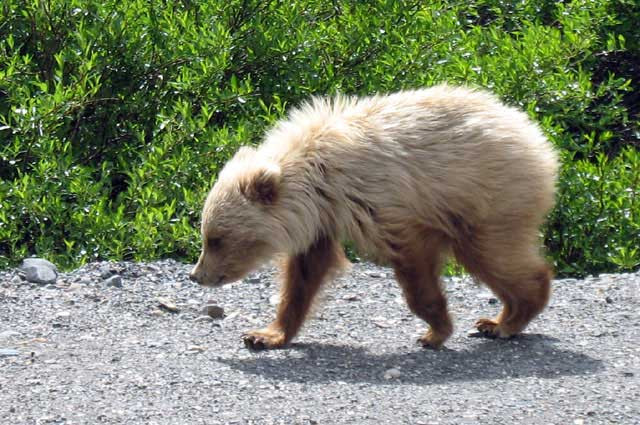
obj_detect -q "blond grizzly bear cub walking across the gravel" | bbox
[191,85,558,349]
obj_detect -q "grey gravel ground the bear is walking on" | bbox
[0,261,640,424]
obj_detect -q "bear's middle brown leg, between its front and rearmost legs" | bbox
[394,235,453,349]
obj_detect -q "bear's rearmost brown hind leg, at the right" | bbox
[454,225,552,338]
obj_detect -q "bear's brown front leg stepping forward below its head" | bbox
[244,238,348,350]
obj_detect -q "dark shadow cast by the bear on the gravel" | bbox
[218,334,603,385]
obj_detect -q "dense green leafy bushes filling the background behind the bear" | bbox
[0,0,640,275]
